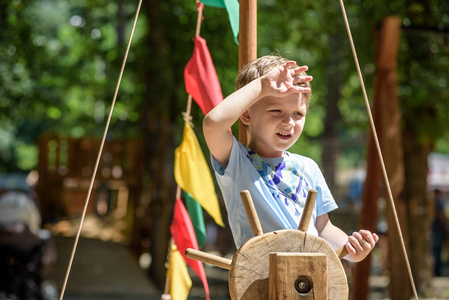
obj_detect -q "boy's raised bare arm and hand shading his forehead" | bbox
[203,61,312,168]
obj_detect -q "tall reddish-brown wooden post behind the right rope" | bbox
[375,17,412,300]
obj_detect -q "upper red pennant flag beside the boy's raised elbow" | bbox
[184,36,223,115]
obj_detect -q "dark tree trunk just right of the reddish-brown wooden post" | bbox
[402,0,437,294]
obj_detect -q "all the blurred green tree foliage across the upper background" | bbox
[0,0,449,171]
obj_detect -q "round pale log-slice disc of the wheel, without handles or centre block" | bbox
[229,229,349,300]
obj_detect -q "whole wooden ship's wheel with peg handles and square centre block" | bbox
[186,190,349,300]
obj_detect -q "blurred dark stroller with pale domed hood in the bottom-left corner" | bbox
[0,192,55,300]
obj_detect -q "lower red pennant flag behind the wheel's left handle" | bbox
[170,198,210,300]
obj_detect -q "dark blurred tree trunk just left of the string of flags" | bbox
[142,0,178,289]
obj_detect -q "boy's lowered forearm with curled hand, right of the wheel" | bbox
[316,214,379,262]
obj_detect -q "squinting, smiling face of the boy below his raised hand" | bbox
[242,94,307,158]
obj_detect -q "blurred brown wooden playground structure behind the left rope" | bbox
[36,134,144,244]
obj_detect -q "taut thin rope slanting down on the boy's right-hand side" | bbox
[339,0,418,300]
